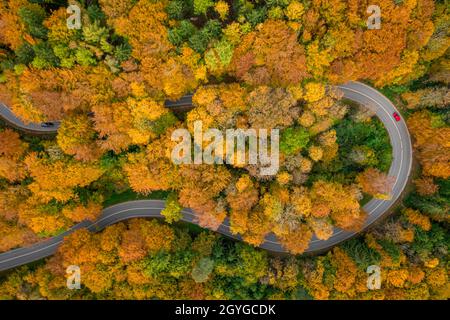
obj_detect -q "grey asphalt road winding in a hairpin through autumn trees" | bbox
[0,82,412,271]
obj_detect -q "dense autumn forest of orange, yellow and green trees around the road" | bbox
[0,0,450,299]
